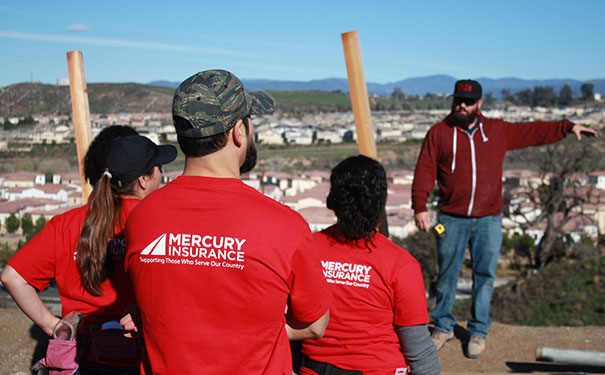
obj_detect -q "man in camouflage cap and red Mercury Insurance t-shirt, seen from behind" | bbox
[125,70,330,374]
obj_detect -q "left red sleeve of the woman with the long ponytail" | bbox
[8,219,62,291]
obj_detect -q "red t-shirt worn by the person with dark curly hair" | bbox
[301,226,429,374]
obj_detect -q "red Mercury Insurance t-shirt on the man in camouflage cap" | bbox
[126,176,330,375]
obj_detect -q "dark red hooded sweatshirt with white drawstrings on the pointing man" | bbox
[412,116,575,217]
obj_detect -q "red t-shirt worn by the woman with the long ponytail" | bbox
[8,199,139,323]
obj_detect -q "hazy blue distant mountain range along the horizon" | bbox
[149,75,605,98]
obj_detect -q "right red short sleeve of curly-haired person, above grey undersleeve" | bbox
[393,255,429,326]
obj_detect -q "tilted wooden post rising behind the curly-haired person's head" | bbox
[340,31,389,237]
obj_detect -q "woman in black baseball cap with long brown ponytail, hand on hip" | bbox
[2,135,177,375]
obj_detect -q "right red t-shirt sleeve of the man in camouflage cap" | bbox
[290,239,331,322]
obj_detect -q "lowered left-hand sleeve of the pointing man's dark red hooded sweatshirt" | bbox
[412,127,438,214]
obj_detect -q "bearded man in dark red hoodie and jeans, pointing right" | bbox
[412,80,597,358]
